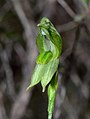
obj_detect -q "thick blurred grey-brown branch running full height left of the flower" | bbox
[11,0,36,119]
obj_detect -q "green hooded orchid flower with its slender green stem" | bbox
[27,17,62,119]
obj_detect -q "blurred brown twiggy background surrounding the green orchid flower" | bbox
[0,0,90,119]
